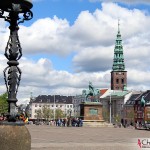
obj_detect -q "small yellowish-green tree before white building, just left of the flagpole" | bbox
[42,105,53,120]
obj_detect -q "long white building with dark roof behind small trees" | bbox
[28,95,74,120]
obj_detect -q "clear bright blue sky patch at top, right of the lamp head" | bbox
[32,0,101,24]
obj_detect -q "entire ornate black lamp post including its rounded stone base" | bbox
[0,0,33,150]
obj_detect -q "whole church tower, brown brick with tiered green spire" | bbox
[111,20,127,90]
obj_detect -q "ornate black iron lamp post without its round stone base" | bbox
[0,0,33,122]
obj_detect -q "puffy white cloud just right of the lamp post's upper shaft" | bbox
[19,16,71,55]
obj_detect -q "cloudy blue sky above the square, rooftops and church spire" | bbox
[0,0,150,103]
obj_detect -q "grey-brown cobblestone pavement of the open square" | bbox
[27,125,150,150]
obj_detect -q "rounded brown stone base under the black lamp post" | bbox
[0,121,31,150]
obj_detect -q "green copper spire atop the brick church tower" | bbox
[112,20,125,71]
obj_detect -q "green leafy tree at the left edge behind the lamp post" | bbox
[0,93,8,114]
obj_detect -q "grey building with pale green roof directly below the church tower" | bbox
[100,89,131,123]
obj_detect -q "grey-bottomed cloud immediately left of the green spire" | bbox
[73,46,114,72]
